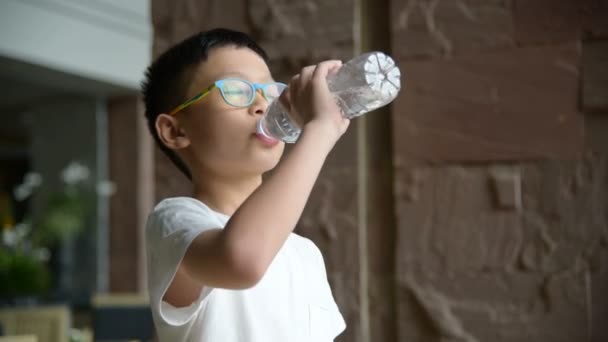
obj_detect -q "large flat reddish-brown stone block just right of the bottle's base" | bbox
[392,44,584,163]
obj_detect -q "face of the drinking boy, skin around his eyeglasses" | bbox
[177,46,284,176]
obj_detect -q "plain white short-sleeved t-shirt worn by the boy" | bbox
[146,197,346,342]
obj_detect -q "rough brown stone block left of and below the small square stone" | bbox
[396,166,523,274]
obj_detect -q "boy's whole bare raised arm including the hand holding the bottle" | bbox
[167,61,349,304]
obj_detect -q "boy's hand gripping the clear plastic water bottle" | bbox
[280,60,350,140]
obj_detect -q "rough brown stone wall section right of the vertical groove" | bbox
[391,0,608,341]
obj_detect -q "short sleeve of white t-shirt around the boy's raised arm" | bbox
[146,198,223,326]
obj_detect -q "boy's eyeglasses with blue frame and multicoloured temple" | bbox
[169,78,287,115]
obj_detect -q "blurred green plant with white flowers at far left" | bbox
[0,162,114,298]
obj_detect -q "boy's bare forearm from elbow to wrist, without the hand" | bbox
[223,127,335,278]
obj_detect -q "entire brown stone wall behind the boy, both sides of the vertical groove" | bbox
[152,0,608,342]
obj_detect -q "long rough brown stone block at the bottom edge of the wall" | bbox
[398,269,590,342]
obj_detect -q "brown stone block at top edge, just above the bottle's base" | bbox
[391,0,514,59]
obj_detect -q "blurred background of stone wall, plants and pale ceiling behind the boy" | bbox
[0,0,608,342]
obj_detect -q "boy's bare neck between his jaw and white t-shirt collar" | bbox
[193,175,262,216]
